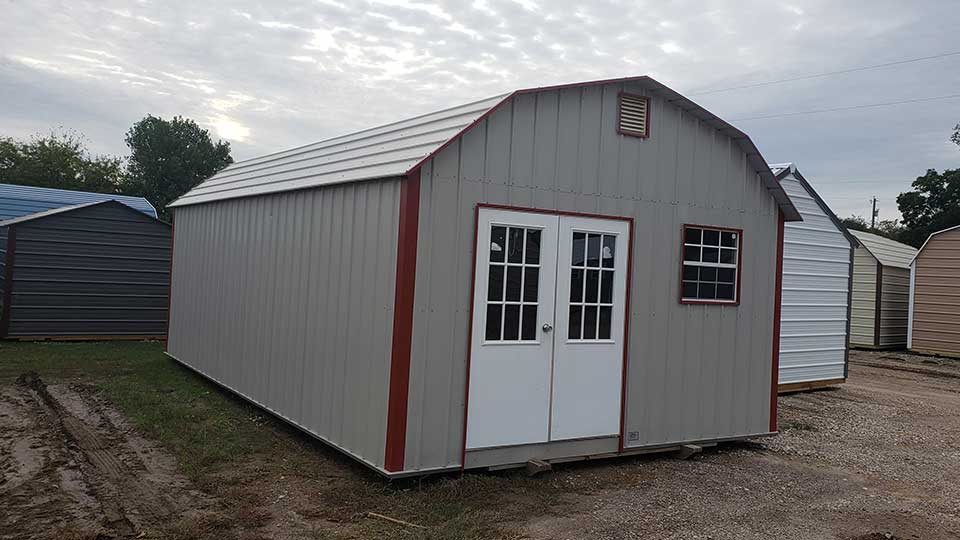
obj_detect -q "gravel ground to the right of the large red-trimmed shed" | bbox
[524,351,960,539]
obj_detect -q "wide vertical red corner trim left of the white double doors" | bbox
[384,169,420,472]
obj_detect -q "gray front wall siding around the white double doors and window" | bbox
[405,83,778,470]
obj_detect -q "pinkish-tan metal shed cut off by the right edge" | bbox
[907,225,960,357]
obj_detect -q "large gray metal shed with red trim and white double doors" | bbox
[167,77,800,477]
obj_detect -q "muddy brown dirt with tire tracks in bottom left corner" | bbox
[0,374,209,538]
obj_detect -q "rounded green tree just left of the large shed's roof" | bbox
[126,115,233,220]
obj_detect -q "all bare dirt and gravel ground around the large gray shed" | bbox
[0,352,960,540]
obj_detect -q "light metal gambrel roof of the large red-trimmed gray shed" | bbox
[170,76,801,221]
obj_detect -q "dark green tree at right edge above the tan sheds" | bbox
[897,169,960,247]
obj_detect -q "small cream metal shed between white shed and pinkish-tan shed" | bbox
[850,231,917,349]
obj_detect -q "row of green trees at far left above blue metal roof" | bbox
[0,130,127,193]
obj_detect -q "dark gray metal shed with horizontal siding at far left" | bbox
[0,200,171,339]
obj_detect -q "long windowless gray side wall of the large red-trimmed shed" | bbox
[167,179,401,468]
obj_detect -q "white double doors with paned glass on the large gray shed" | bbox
[466,208,630,449]
